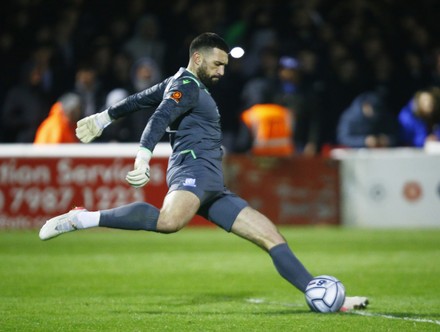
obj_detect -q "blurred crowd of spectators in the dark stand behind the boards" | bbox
[0,0,440,155]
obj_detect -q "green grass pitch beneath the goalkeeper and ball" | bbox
[0,227,440,332]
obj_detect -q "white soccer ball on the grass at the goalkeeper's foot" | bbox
[305,275,345,313]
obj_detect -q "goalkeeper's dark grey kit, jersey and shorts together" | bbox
[109,68,247,231]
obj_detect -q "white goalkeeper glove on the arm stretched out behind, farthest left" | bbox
[76,111,112,143]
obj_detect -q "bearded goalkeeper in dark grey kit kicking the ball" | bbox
[40,33,366,309]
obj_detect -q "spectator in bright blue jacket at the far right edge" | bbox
[398,87,440,147]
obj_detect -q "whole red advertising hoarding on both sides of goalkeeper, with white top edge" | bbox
[0,144,339,229]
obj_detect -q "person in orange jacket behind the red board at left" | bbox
[34,93,81,144]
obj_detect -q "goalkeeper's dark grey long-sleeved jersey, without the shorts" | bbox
[109,68,222,158]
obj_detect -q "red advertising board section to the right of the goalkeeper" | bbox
[225,156,340,225]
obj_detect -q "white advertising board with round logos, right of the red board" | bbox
[332,149,440,228]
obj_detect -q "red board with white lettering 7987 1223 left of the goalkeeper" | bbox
[0,157,167,228]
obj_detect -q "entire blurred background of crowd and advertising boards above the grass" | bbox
[0,0,440,228]
